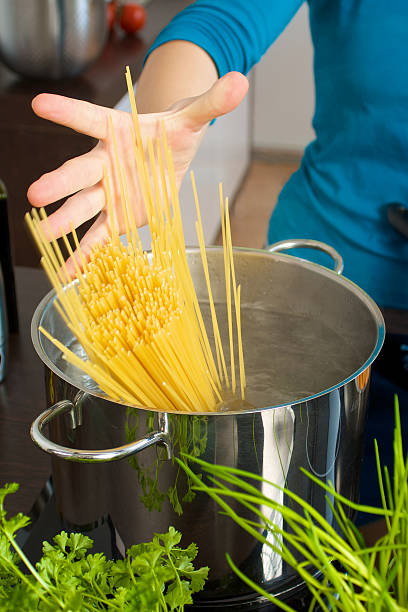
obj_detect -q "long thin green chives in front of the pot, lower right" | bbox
[178,399,408,612]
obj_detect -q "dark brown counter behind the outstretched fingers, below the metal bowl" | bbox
[0,0,190,266]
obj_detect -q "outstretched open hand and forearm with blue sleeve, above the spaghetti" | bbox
[27,0,302,268]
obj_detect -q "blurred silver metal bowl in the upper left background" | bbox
[0,0,108,79]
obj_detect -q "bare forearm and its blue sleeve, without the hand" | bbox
[136,0,304,113]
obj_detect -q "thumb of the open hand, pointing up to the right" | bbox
[177,72,249,129]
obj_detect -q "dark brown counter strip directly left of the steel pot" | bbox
[0,267,51,514]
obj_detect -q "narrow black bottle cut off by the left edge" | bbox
[0,179,18,333]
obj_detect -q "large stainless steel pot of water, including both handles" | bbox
[32,241,384,609]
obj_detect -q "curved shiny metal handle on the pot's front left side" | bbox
[30,400,171,463]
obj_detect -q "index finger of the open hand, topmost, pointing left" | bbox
[31,94,112,140]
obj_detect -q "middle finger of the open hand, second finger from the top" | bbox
[27,148,105,207]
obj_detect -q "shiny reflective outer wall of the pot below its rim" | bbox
[42,378,365,601]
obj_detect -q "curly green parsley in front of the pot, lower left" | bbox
[0,484,208,612]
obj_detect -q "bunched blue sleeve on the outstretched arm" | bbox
[148,0,304,77]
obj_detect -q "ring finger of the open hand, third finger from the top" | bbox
[42,183,105,239]
